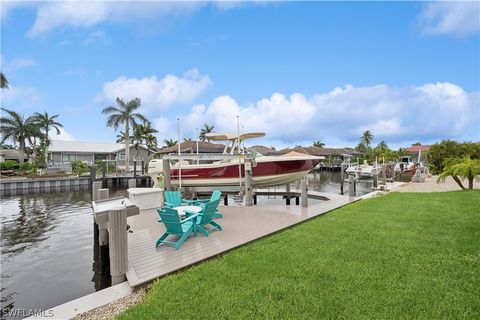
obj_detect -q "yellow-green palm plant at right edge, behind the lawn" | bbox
[437,156,480,190]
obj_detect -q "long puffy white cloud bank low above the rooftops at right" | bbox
[176,82,480,144]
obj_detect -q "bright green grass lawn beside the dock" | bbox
[119,191,480,319]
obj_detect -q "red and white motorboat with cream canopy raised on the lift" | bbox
[148,132,325,187]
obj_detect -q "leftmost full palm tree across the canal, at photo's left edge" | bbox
[0,108,34,163]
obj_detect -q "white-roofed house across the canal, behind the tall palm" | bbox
[48,140,156,169]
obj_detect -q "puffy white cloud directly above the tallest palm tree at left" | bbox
[101,69,212,112]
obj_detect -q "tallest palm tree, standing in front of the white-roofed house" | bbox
[102,97,147,172]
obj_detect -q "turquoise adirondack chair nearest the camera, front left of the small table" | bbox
[155,207,200,250]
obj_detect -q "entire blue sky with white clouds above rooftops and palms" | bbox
[1,1,480,147]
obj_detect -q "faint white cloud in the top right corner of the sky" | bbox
[418,1,480,38]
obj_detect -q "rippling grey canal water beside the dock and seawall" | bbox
[0,172,371,319]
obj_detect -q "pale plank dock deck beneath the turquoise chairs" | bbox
[126,191,349,288]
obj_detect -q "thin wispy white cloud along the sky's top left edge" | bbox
[14,0,273,38]
